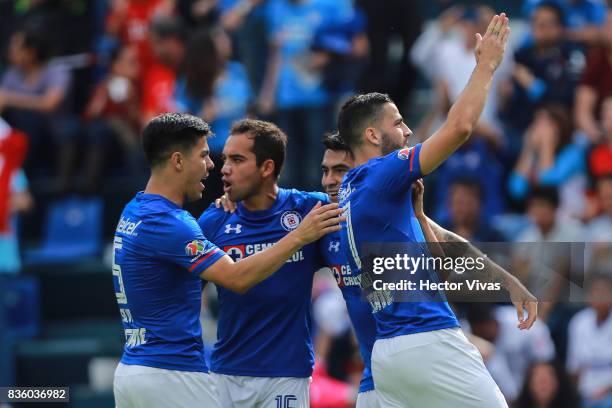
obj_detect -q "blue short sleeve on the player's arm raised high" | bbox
[370,144,422,190]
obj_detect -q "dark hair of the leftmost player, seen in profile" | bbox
[142,113,211,168]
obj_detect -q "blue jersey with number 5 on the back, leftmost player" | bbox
[113,192,224,372]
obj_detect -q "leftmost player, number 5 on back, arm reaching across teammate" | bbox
[113,114,341,408]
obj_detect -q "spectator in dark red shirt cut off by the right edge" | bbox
[574,8,612,143]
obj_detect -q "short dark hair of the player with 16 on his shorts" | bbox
[230,119,287,177]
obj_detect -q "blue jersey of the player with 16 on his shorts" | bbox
[198,189,329,378]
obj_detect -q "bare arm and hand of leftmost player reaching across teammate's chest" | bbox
[200,203,343,293]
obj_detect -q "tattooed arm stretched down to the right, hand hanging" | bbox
[428,218,538,330]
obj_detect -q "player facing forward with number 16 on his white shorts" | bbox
[199,119,329,408]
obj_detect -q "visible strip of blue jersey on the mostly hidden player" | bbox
[322,232,376,392]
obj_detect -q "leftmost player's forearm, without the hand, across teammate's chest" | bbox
[230,232,304,293]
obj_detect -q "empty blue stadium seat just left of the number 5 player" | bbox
[25,196,102,265]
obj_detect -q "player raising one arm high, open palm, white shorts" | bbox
[339,14,537,408]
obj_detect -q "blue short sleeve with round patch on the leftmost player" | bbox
[155,218,225,275]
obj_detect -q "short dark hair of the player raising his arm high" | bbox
[338,92,393,150]
